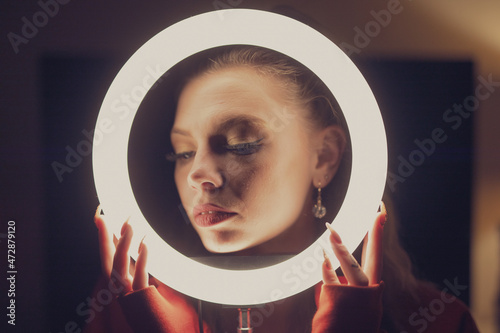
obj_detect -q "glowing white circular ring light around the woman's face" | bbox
[93,9,387,305]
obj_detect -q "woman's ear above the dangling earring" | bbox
[313,125,347,187]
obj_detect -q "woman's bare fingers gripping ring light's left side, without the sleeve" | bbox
[94,206,148,295]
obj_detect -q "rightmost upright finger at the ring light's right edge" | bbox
[362,202,387,284]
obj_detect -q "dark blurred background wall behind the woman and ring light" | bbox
[0,0,500,333]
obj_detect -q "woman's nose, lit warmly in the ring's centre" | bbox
[188,149,225,193]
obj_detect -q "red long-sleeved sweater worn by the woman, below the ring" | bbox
[85,276,479,333]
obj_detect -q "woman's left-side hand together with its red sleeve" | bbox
[92,207,210,332]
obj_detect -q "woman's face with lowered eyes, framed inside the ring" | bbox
[171,67,316,253]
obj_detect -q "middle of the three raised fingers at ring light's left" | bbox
[113,221,133,293]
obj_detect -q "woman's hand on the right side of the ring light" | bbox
[323,203,387,286]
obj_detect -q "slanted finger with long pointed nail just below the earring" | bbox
[326,223,368,286]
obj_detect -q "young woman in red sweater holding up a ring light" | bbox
[87,46,477,333]
